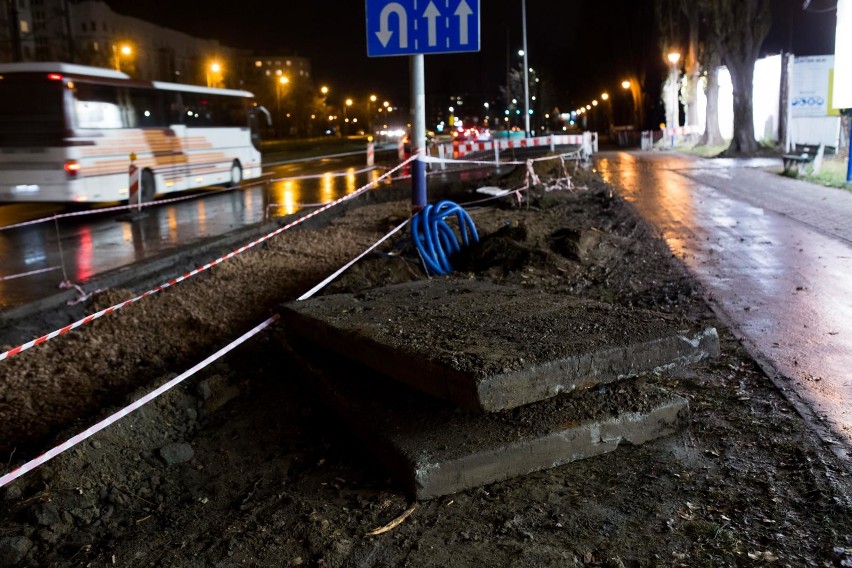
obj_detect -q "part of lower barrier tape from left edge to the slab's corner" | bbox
[0,314,279,487]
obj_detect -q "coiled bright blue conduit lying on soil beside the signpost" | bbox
[411,201,479,275]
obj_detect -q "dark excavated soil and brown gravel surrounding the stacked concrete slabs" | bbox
[0,158,852,568]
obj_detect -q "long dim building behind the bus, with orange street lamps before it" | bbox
[0,0,311,95]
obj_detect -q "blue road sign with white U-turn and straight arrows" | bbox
[366,0,479,57]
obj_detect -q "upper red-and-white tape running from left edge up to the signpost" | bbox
[0,158,413,361]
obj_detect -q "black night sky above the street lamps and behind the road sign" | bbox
[106,0,836,117]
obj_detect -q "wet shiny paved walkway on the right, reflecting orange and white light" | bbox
[595,152,852,455]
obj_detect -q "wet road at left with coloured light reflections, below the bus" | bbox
[0,159,382,310]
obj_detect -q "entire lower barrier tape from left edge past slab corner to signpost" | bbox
[0,211,410,487]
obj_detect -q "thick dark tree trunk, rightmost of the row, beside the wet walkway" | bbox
[702,0,772,154]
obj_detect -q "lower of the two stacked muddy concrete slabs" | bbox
[283,341,689,499]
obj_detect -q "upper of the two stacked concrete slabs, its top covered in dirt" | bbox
[282,277,719,412]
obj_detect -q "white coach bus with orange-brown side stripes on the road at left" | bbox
[0,63,265,203]
